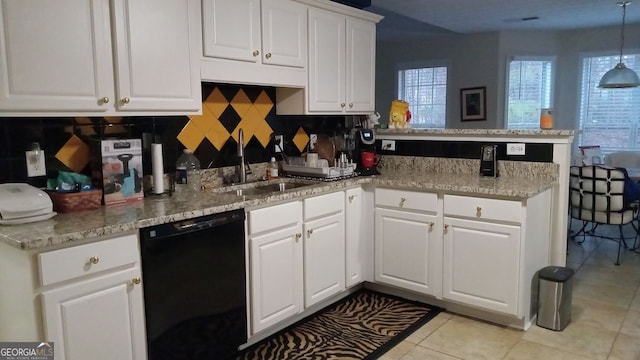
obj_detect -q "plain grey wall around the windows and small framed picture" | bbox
[376,24,640,129]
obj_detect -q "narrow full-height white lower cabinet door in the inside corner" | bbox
[344,188,365,287]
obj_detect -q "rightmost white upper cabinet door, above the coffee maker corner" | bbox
[345,18,376,113]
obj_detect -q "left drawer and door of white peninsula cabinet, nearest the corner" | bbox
[375,189,442,296]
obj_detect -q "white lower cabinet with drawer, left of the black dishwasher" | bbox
[38,235,146,360]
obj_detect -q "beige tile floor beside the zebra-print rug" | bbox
[380,222,640,360]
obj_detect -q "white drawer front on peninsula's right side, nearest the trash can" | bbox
[444,195,522,223]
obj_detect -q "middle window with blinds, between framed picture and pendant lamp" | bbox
[507,58,554,129]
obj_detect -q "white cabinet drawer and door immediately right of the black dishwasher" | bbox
[247,201,303,334]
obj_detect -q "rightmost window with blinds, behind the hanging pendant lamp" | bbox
[578,54,640,154]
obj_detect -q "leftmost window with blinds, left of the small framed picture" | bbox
[398,66,447,128]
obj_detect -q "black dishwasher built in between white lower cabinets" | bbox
[140,210,247,360]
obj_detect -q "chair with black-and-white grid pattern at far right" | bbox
[569,165,638,265]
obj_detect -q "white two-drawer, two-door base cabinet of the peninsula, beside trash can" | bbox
[375,188,551,328]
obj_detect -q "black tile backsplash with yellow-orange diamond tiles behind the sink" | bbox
[0,83,350,186]
